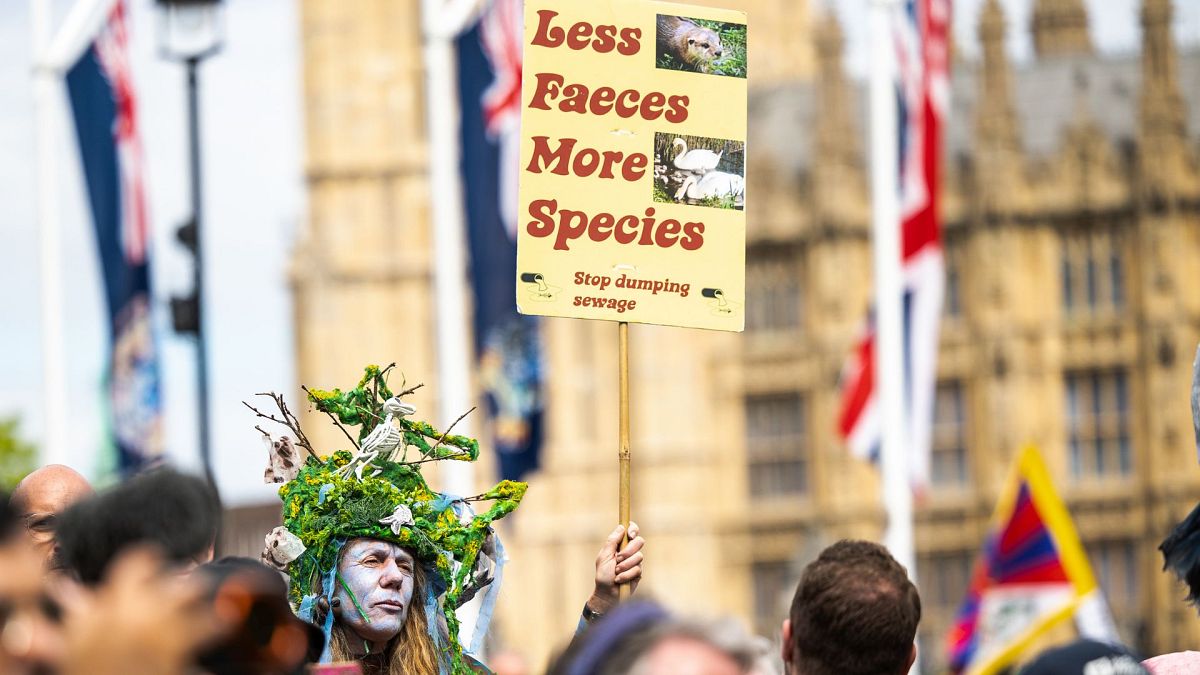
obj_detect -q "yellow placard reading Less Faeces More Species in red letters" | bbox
[516,0,746,330]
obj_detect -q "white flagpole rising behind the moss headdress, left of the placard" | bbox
[421,0,481,640]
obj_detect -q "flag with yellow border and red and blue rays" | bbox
[947,447,1117,675]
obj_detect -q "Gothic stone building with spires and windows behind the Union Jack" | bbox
[738,0,1200,669]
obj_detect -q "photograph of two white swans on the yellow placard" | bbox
[653,132,746,210]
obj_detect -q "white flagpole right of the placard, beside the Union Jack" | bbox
[870,0,916,578]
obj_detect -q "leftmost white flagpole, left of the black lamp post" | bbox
[30,0,67,465]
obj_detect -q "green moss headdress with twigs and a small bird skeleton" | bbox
[251,365,527,673]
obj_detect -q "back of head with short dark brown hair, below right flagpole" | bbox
[790,540,920,675]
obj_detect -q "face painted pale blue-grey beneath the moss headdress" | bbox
[334,539,414,643]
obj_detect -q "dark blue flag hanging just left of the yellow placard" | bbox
[456,0,542,480]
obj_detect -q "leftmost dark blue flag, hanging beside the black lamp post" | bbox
[66,1,162,474]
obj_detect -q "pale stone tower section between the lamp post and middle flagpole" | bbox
[290,0,437,447]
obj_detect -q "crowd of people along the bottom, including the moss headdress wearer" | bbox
[0,355,1200,675]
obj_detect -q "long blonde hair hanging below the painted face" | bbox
[329,551,439,675]
